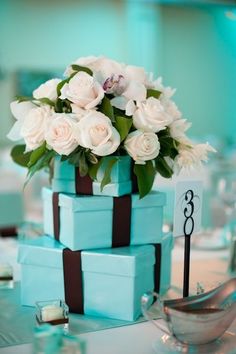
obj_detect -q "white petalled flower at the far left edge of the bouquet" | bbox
[7,101,36,141]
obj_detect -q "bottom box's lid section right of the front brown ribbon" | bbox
[82,245,155,276]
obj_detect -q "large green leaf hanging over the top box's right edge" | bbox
[134,161,156,199]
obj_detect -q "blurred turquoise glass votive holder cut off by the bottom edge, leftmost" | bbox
[33,323,63,354]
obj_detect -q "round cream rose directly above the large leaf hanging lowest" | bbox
[124,130,160,165]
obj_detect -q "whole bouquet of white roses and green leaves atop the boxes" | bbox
[8,57,214,197]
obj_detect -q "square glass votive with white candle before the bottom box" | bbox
[35,300,69,330]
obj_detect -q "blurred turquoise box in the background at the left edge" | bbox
[0,192,24,228]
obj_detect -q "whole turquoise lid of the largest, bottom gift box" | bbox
[18,236,155,276]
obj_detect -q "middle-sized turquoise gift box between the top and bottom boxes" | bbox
[42,188,165,251]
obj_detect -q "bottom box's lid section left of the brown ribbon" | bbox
[18,236,65,268]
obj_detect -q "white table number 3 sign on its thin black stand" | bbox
[173,181,203,297]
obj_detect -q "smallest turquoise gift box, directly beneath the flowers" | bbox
[52,156,132,197]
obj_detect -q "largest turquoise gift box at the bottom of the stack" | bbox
[18,234,173,321]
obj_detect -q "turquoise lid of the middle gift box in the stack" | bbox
[59,192,166,211]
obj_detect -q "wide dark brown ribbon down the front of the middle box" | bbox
[112,195,132,247]
